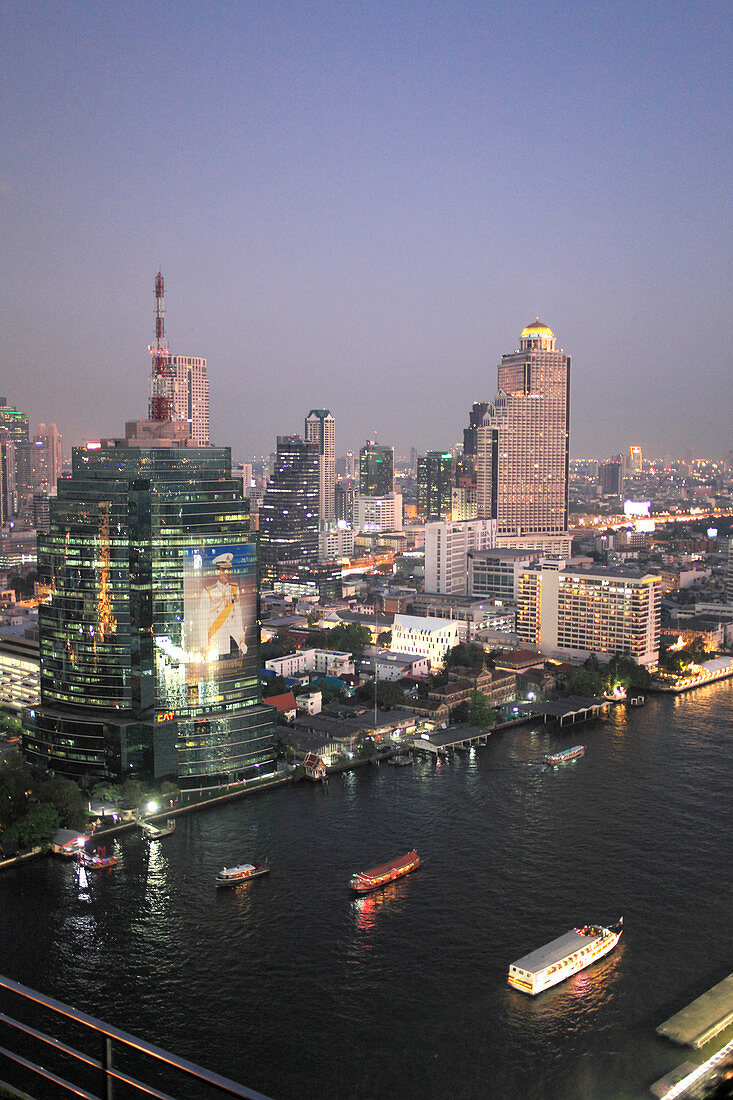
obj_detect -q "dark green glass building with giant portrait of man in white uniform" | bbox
[23,421,275,790]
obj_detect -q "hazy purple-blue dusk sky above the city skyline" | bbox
[0,0,733,459]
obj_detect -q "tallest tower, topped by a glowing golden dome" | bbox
[477,319,570,538]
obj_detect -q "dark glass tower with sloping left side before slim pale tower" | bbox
[260,436,320,581]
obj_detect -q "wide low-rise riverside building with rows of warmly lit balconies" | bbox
[516,560,661,666]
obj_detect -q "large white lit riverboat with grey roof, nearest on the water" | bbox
[507,916,624,997]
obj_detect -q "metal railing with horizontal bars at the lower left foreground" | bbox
[0,976,267,1100]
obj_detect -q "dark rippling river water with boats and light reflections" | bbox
[0,681,733,1100]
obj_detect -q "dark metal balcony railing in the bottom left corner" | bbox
[0,975,267,1100]
